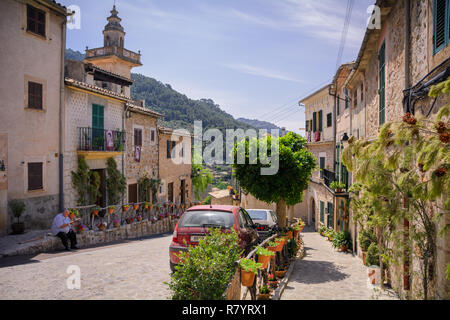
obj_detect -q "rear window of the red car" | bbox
[178,211,234,229]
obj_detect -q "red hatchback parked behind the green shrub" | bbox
[169,205,259,272]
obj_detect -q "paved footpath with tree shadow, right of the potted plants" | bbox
[281,228,397,300]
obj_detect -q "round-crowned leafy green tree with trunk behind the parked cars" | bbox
[233,132,317,227]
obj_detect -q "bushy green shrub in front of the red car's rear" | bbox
[168,229,242,300]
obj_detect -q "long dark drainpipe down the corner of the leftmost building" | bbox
[59,16,67,212]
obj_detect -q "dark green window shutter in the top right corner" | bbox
[433,0,450,54]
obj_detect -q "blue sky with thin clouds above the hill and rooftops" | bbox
[60,0,375,132]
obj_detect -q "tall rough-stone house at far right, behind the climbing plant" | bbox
[344,0,450,298]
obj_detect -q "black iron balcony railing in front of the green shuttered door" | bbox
[78,128,125,152]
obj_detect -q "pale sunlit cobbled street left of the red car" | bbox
[0,234,172,300]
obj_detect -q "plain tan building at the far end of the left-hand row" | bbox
[158,127,193,204]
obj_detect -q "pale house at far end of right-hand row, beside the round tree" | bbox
[300,84,335,229]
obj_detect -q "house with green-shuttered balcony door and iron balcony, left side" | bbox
[64,60,132,208]
